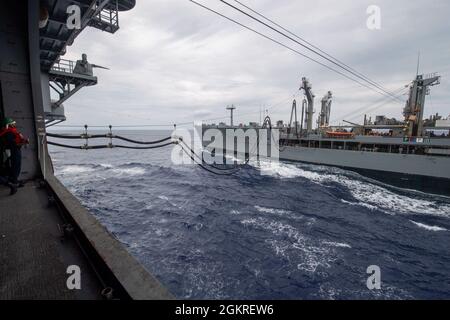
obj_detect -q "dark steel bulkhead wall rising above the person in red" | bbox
[0,1,42,179]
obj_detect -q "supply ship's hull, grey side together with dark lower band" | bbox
[203,128,450,196]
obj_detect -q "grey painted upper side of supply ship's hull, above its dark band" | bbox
[203,127,450,179]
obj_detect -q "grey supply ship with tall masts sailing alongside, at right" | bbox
[203,74,450,194]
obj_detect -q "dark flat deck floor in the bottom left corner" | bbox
[0,182,102,300]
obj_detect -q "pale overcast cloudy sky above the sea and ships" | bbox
[60,0,450,125]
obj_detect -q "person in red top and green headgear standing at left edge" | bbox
[0,118,29,195]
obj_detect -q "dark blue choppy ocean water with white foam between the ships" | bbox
[50,131,450,299]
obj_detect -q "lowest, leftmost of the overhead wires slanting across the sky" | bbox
[188,0,400,98]
